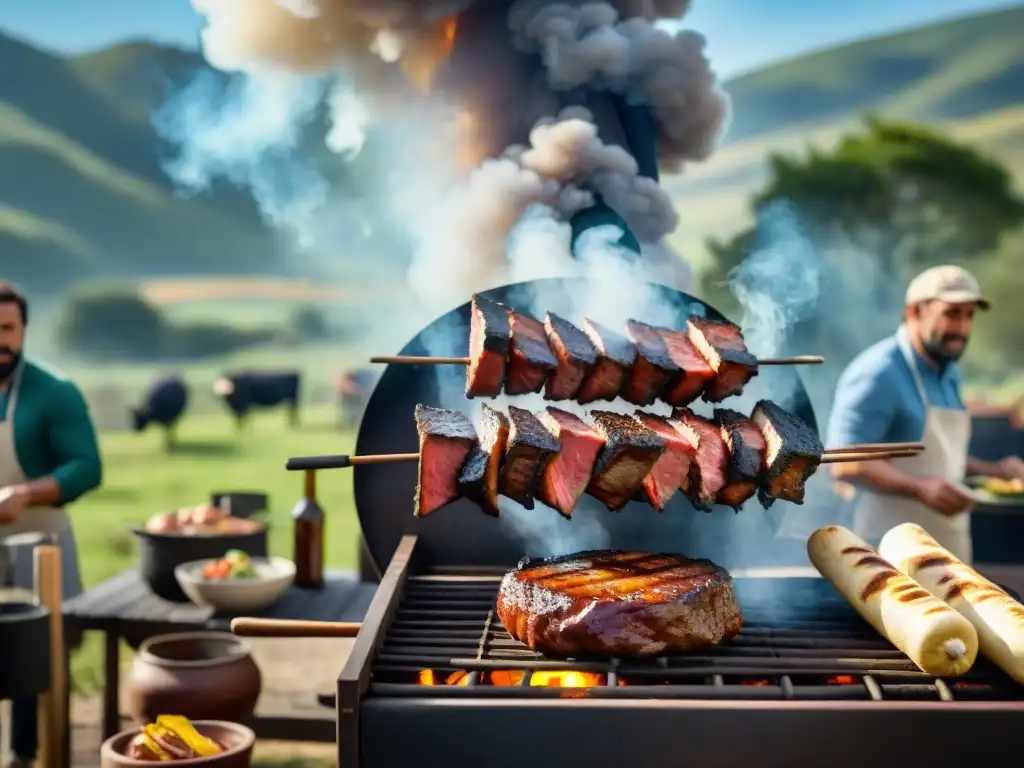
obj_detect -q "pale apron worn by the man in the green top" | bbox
[0,368,82,600]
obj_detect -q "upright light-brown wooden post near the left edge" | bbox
[35,545,68,768]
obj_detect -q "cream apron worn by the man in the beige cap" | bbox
[853,333,972,564]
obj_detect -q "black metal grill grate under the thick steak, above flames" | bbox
[369,575,1024,701]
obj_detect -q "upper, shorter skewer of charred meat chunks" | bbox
[371,295,824,407]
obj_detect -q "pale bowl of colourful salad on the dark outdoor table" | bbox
[174,549,295,613]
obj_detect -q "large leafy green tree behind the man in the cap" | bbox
[710,118,1024,296]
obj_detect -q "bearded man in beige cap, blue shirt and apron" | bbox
[827,265,1024,563]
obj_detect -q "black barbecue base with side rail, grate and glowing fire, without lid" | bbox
[338,537,1024,768]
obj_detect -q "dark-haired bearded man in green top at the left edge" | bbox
[0,283,102,765]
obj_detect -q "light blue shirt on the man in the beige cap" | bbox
[826,326,964,447]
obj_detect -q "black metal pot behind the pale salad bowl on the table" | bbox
[132,526,267,603]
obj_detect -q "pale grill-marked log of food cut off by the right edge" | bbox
[879,522,1024,683]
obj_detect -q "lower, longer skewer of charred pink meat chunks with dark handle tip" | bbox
[288,400,924,517]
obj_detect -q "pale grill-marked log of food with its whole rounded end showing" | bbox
[807,525,978,677]
